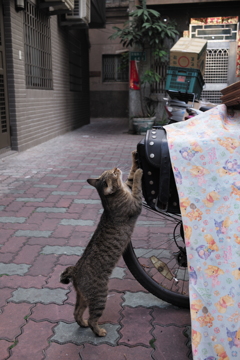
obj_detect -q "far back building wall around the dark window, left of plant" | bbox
[89,2,129,117]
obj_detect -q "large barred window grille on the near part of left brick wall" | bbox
[24,1,53,89]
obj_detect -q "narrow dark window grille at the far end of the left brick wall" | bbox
[68,37,82,91]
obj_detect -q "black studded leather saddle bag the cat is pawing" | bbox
[137,127,180,214]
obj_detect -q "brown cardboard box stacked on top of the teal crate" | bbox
[170,38,207,75]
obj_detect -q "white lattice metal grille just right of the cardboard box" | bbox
[204,49,229,83]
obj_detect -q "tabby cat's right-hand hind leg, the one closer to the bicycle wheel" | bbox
[88,293,107,336]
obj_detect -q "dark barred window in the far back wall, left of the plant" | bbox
[102,53,128,82]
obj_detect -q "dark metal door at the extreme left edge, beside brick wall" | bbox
[0,0,10,150]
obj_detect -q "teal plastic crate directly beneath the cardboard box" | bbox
[165,66,204,99]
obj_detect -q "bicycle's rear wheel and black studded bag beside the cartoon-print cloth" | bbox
[123,127,189,308]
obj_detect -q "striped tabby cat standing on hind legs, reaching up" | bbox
[60,152,142,336]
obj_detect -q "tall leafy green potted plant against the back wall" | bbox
[109,0,178,132]
